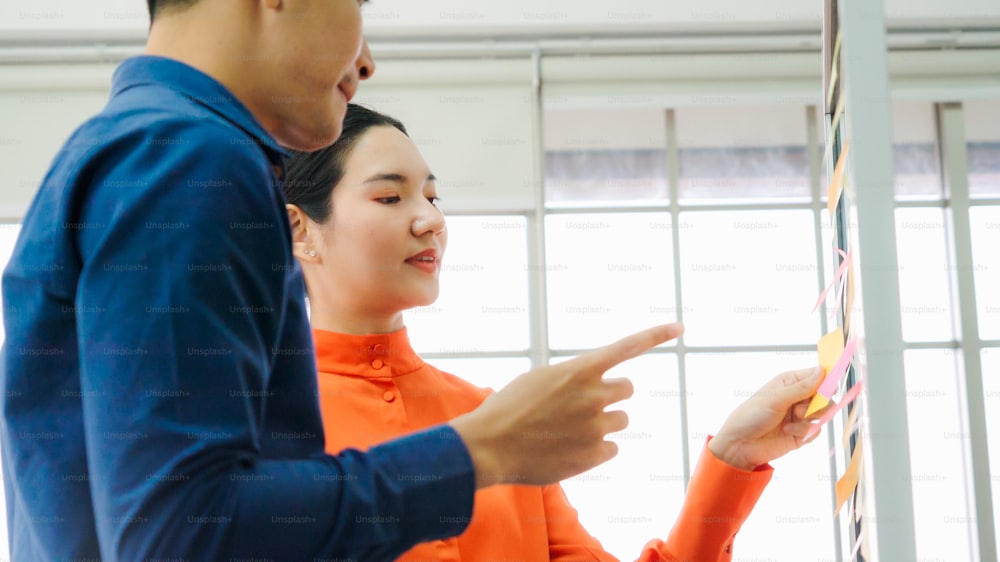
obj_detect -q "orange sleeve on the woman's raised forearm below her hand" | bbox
[639,438,774,562]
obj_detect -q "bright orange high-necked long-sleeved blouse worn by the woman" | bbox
[313,328,772,562]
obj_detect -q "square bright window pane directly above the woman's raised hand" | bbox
[680,210,820,347]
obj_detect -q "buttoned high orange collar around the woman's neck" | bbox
[313,328,424,378]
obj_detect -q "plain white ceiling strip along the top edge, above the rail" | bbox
[0,0,1000,45]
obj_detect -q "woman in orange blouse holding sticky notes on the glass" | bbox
[285,105,820,562]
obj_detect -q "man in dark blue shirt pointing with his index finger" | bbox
[0,0,679,562]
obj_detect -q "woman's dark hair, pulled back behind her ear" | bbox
[284,103,409,224]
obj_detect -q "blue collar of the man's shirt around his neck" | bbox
[111,55,290,163]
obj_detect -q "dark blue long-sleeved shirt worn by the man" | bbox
[0,56,475,562]
